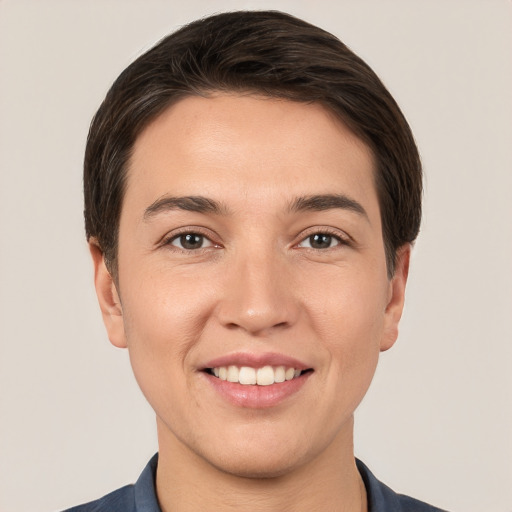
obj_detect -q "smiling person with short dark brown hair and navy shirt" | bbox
[67,12,439,512]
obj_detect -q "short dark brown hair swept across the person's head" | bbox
[84,11,422,276]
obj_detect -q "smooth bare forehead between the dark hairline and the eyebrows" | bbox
[125,94,376,217]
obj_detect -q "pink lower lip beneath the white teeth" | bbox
[204,372,312,409]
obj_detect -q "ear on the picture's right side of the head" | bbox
[380,244,411,352]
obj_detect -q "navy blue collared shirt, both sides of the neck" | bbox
[64,454,443,512]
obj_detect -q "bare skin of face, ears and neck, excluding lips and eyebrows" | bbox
[90,94,410,512]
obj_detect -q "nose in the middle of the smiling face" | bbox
[218,251,300,337]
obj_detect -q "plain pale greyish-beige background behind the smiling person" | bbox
[0,0,512,512]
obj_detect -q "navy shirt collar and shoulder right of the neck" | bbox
[357,460,446,512]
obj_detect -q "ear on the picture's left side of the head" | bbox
[89,239,127,348]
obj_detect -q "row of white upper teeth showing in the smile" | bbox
[211,365,302,386]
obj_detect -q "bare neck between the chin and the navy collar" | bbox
[156,416,367,512]
